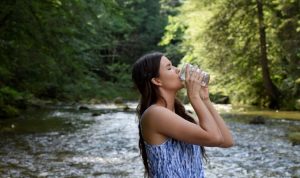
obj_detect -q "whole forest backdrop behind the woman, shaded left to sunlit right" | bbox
[0,0,300,118]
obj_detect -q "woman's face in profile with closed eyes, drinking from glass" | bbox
[158,56,184,90]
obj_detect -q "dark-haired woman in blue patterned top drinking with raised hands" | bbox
[132,52,233,178]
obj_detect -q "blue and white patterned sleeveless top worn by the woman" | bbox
[145,138,204,178]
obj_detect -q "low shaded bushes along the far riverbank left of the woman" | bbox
[0,82,138,120]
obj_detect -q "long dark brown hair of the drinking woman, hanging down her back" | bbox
[132,52,207,175]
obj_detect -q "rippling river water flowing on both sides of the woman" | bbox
[0,103,300,178]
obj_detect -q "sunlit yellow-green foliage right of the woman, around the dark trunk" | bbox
[161,0,300,109]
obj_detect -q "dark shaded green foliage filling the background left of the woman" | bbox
[0,0,176,117]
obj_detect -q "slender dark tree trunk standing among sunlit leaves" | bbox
[256,0,279,109]
